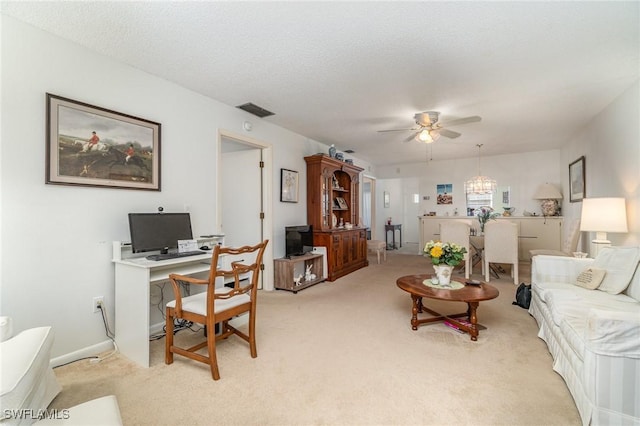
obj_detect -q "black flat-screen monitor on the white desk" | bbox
[129,213,193,254]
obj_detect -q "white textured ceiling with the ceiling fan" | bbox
[1,1,640,165]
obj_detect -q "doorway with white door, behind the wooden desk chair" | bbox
[216,130,273,290]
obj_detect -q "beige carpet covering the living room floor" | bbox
[51,252,580,425]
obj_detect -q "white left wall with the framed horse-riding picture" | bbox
[0,15,367,357]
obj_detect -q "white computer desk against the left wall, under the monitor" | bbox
[112,241,226,368]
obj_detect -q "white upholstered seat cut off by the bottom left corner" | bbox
[0,317,122,426]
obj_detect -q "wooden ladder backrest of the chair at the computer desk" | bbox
[207,240,269,307]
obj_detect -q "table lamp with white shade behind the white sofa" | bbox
[580,198,628,257]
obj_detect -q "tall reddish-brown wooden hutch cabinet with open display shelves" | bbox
[304,154,369,281]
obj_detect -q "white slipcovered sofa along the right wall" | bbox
[529,247,640,426]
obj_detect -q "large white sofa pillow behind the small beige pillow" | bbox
[592,247,640,294]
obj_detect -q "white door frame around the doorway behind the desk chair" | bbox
[216,129,274,290]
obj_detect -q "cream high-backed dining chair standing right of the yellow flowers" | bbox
[483,220,518,284]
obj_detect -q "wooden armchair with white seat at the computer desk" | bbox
[165,240,269,380]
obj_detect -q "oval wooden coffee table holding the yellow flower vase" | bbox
[396,275,500,341]
